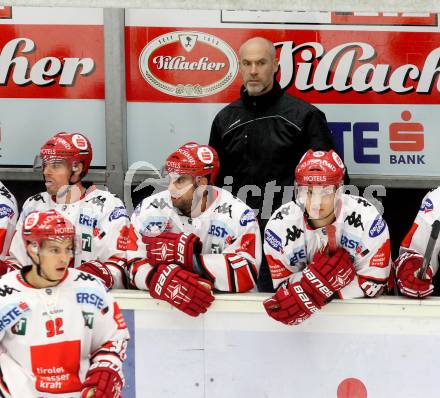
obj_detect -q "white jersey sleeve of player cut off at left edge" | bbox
[0,182,18,260]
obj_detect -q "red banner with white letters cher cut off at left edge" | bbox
[0,25,104,99]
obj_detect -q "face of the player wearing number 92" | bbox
[39,239,73,282]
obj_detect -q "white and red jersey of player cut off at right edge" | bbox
[399,187,440,275]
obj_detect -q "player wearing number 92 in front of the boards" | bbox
[0,210,128,398]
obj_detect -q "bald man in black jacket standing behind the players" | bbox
[209,37,334,291]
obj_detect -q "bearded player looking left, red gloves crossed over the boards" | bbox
[129,142,261,316]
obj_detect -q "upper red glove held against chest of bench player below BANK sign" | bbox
[301,247,356,305]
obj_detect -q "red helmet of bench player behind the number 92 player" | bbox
[40,133,93,176]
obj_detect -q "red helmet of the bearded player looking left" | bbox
[165,142,220,184]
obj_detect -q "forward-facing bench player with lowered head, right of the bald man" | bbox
[264,150,390,325]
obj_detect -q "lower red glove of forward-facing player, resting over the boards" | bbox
[263,282,321,325]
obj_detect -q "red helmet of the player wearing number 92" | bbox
[22,210,75,246]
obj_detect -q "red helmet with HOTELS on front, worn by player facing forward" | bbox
[295,149,345,186]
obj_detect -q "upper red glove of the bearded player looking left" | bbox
[142,232,202,272]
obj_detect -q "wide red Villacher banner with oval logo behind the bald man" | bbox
[126,26,440,104]
